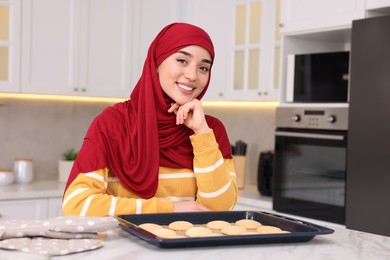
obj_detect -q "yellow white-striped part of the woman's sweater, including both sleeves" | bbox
[62,130,238,216]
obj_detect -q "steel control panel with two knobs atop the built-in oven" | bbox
[276,107,348,130]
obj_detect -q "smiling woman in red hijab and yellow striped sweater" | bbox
[63,23,237,216]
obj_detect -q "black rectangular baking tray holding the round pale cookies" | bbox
[118,211,334,248]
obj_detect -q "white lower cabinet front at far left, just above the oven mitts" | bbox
[0,199,47,219]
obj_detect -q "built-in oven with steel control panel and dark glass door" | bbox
[273,107,348,224]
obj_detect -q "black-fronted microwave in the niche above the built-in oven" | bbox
[285,51,349,103]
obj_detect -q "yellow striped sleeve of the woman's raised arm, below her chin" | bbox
[190,130,238,211]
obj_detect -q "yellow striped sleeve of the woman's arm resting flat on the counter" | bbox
[62,168,173,216]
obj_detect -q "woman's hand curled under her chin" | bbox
[168,99,210,134]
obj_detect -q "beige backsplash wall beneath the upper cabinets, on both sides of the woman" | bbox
[0,98,275,184]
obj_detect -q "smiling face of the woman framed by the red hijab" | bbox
[157,45,212,105]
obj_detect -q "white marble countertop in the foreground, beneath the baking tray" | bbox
[52,225,390,260]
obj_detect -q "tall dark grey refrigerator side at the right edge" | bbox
[346,16,390,236]
